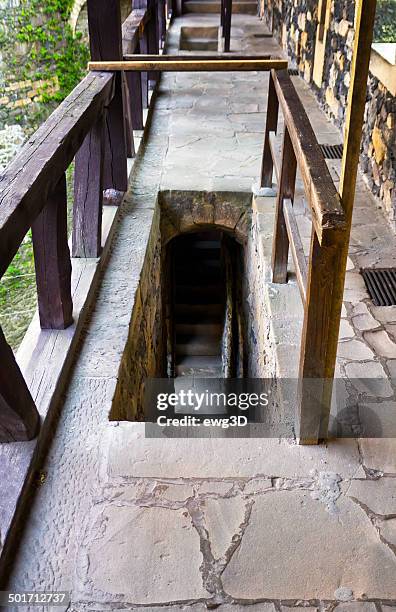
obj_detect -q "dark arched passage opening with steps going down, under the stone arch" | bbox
[168,230,243,378]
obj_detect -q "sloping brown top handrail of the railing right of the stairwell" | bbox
[271,71,346,244]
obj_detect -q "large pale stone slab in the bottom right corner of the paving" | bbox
[222,491,396,600]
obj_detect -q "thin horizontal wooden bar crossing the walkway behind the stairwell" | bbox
[88,59,287,72]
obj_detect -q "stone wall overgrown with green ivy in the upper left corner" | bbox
[0,0,88,133]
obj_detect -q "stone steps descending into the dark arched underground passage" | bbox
[173,232,225,378]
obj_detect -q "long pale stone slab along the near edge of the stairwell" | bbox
[103,422,359,479]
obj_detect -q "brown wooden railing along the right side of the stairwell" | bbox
[261,71,349,443]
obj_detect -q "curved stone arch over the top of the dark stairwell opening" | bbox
[158,191,252,245]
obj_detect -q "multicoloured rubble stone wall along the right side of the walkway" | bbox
[261,0,396,225]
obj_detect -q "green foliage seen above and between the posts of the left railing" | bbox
[0,0,89,349]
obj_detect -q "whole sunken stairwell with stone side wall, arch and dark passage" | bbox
[109,191,252,421]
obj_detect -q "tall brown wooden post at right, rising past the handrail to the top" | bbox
[297,0,376,444]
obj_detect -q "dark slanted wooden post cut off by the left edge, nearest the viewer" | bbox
[0,328,40,442]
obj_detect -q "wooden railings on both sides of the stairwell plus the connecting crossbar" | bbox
[0,0,345,448]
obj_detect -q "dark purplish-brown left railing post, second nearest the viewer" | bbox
[32,174,73,329]
